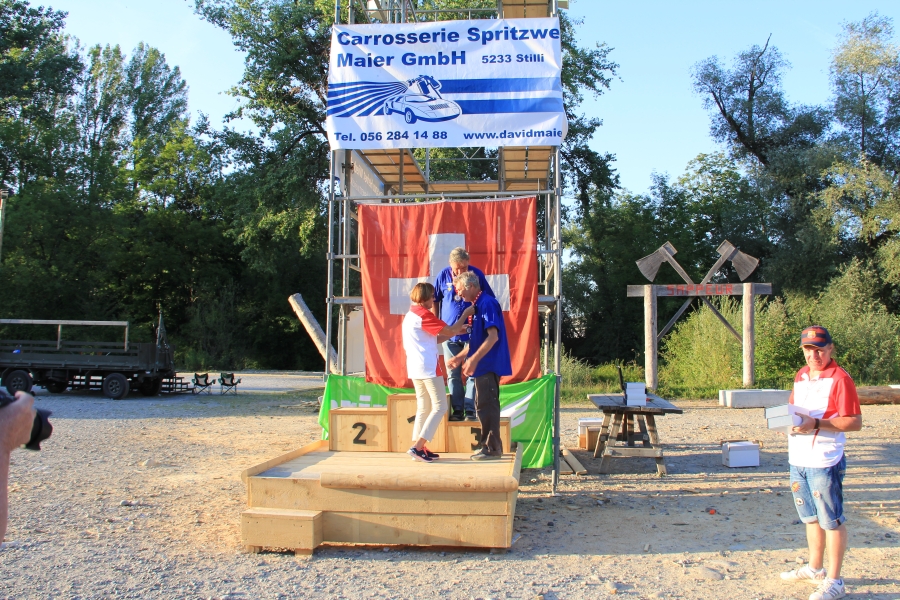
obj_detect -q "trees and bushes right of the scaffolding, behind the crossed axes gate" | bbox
[564,14,900,395]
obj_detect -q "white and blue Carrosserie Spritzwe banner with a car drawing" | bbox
[326,18,567,150]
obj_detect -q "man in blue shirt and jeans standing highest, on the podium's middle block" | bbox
[432,248,494,421]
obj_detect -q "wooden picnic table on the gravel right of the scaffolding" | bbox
[588,394,684,475]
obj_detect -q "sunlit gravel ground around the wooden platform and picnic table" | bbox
[0,389,900,599]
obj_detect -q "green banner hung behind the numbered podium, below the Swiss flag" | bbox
[319,373,556,469]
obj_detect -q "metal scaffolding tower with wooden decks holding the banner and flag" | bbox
[325,0,567,494]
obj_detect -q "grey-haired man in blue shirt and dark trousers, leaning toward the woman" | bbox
[448,271,512,460]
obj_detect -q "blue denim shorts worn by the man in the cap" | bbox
[791,456,847,529]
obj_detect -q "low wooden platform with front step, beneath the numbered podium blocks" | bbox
[241,441,522,554]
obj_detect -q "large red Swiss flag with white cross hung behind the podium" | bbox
[359,197,540,388]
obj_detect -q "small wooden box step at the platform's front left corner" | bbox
[241,508,322,554]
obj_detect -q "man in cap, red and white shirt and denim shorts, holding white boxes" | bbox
[781,325,862,600]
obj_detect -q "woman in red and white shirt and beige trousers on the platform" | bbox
[402,283,475,462]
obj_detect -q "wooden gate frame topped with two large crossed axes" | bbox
[628,240,772,389]
